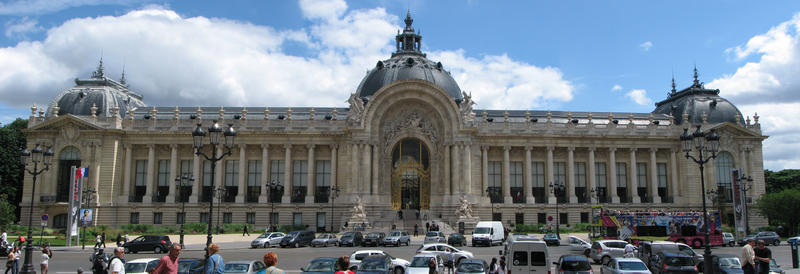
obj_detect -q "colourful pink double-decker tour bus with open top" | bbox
[590,209,723,248]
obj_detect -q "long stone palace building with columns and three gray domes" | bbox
[20,16,767,230]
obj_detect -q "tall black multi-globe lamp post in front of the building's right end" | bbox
[680,125,719,274]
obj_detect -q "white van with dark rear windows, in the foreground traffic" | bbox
[500,240,551,274]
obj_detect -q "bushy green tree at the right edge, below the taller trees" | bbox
[756,189,800,235]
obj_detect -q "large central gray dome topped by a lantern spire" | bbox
[356,13,464,102]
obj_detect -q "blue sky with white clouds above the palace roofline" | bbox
[0,0,800,170]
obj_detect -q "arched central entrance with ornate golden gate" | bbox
[392,138,431,210]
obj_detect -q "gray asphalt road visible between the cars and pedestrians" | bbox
[43,240,800,274]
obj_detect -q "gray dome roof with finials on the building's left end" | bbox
[47,60,145,117]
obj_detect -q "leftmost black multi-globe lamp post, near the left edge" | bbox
[19,144,54,274]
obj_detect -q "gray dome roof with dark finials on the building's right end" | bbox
[653,69,744,125]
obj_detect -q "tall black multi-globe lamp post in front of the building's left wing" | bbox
[192,120,236,273]
